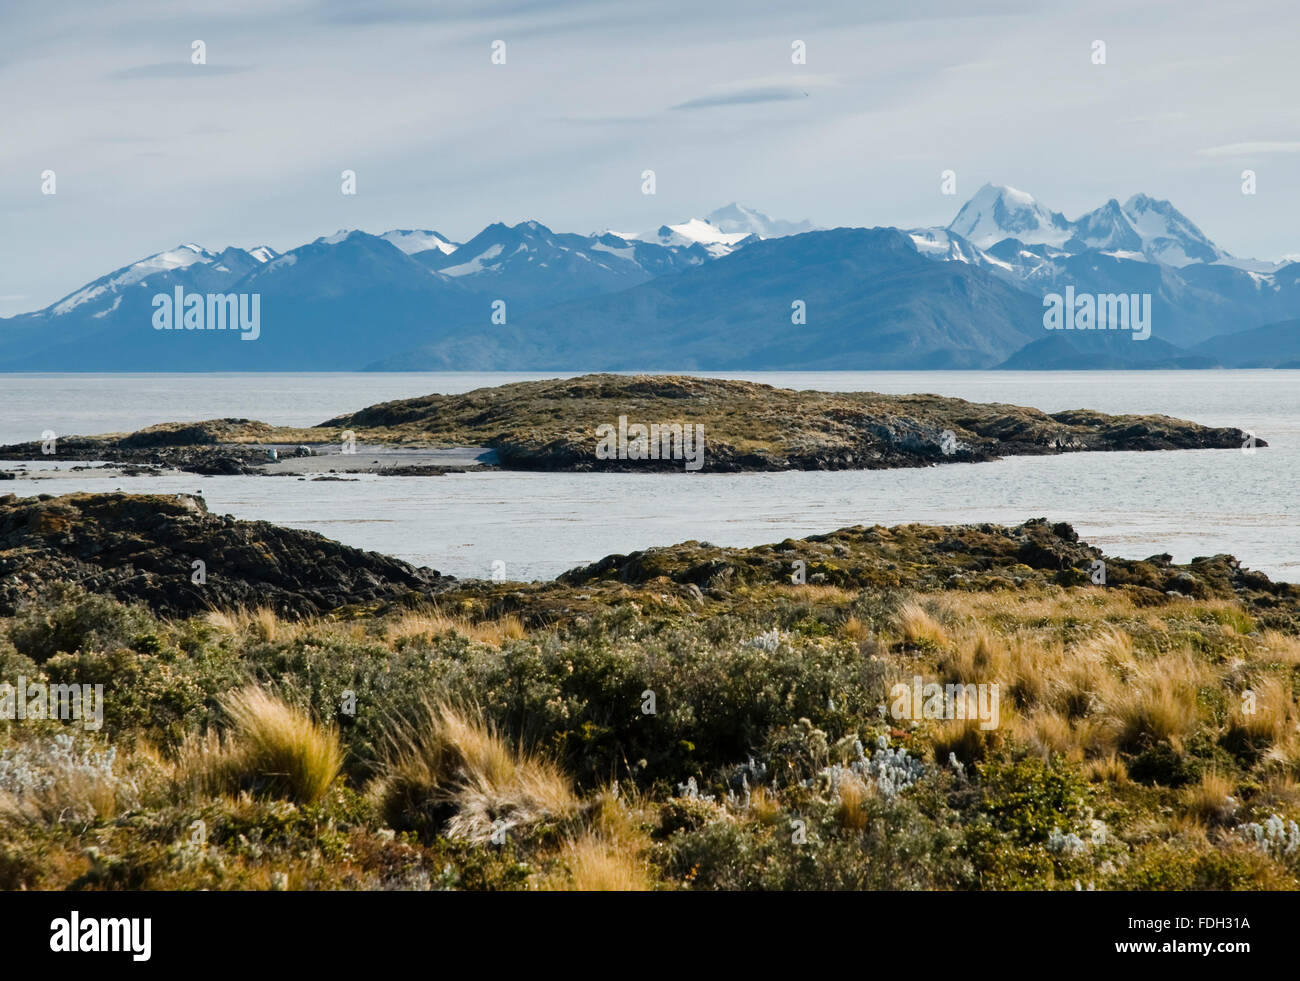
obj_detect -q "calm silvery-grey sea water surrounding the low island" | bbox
[0,372,1300,581]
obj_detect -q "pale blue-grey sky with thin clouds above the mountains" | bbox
[0,0,1300,317]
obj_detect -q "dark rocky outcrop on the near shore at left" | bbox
[0,494,451,616]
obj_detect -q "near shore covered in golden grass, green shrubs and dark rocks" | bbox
[0,491,1300,890]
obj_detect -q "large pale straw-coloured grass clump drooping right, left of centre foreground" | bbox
[373,703,577,843]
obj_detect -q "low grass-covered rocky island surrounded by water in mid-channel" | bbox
[0,374,1266,473]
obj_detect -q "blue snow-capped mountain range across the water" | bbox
[0,185,1300,370]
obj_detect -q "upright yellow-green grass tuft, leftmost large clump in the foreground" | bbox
[177,686,343,804]
